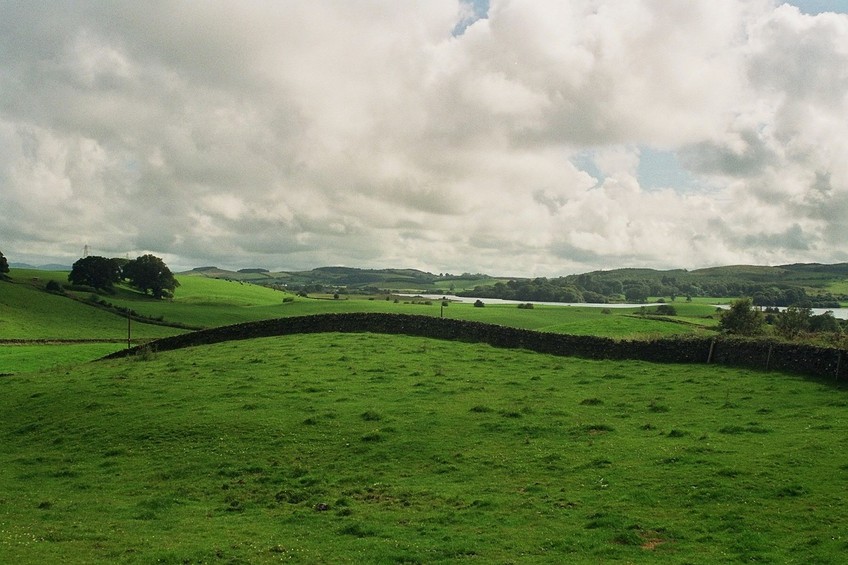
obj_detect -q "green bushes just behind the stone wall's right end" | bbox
[718,298,848,339]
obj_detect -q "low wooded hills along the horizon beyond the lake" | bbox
[177,263,848,307]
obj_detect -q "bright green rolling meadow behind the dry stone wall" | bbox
[0,269,717,374]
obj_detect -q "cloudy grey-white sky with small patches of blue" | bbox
[0,0,848,276]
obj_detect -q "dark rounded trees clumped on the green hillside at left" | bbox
[68,254,180,298]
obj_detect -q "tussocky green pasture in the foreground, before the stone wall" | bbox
[0,334,848,564]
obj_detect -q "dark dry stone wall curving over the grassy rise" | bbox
[105,313,848,380]
